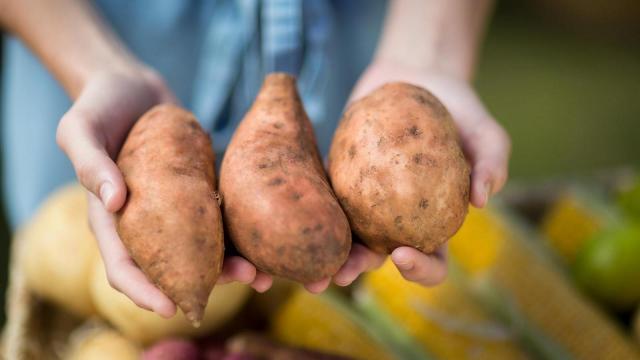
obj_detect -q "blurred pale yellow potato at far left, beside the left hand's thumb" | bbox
[16,184,98,316]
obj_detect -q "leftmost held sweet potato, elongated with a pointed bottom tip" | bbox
[117,105,224,324]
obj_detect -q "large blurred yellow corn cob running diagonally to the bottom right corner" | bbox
[450,208,640,359]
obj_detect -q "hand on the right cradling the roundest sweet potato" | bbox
[307,60,511,292]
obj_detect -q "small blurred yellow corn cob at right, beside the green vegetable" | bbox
[541,188,617,265]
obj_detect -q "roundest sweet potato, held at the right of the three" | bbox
[329,83,470,253]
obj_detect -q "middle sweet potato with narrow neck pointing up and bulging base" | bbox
[220,74,351,283]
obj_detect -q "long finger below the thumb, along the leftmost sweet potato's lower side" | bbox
[89,194,176,318]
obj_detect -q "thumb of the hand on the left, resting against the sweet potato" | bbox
[56,107,127,212]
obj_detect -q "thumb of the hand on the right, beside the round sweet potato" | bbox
[463,120,511,208]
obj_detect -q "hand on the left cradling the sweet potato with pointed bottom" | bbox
[56,66,271,317]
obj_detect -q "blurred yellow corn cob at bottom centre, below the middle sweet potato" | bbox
[271,290,399,360]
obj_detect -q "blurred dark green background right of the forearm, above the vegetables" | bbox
[0,0,640,322]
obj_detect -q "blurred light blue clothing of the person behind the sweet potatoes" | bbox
[2,0,385,226]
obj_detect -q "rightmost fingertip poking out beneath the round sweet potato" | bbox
[391,246,447,286]
